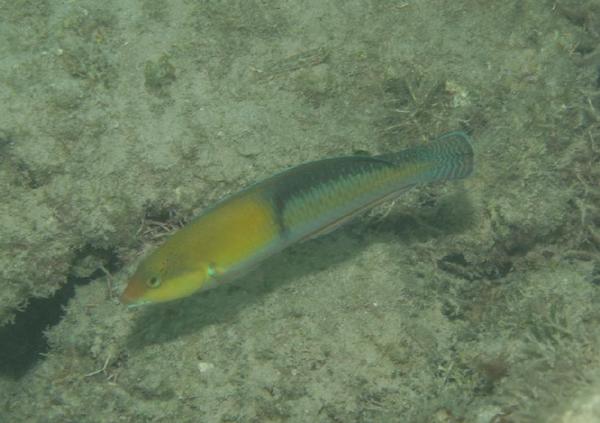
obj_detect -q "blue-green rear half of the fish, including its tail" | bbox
[264,132,473,243]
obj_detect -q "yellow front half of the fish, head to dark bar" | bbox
[121,189,280,305]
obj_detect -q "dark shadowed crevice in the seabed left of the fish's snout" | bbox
[0,246,121,380]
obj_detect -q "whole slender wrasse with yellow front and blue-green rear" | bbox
[121,132,473,305]
